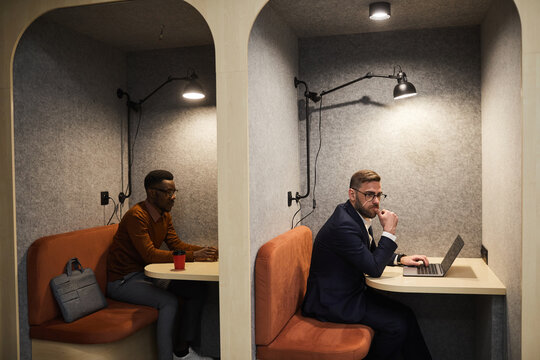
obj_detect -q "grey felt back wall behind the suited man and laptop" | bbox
[299,27,482,257]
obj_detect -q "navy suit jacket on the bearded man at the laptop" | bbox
[302,201,397,323]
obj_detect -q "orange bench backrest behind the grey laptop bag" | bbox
[27,225,118,325]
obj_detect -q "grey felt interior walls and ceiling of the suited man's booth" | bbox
[248,0,522,359]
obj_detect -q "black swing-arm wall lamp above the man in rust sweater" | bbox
[116,70,205,204]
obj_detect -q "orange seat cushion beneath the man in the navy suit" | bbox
[257,310,374,360]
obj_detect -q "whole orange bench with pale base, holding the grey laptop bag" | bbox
[27,225,158,360]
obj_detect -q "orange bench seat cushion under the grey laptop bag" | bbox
[30,298,158,344]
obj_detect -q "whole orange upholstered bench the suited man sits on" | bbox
[255,226,374,360]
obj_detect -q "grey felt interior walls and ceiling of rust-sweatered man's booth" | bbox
[13,0,219,359]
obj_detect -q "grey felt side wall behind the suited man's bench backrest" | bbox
[248,6,300,354]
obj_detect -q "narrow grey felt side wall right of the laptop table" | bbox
[481,0,526,359]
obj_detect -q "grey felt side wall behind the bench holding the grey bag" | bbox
[13,20,126,360]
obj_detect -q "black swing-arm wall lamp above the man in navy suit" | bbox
[287,65,416,206]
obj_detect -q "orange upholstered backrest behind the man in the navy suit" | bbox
[255,226,313,345]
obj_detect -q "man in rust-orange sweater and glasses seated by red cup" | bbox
[107,170,218,360]
